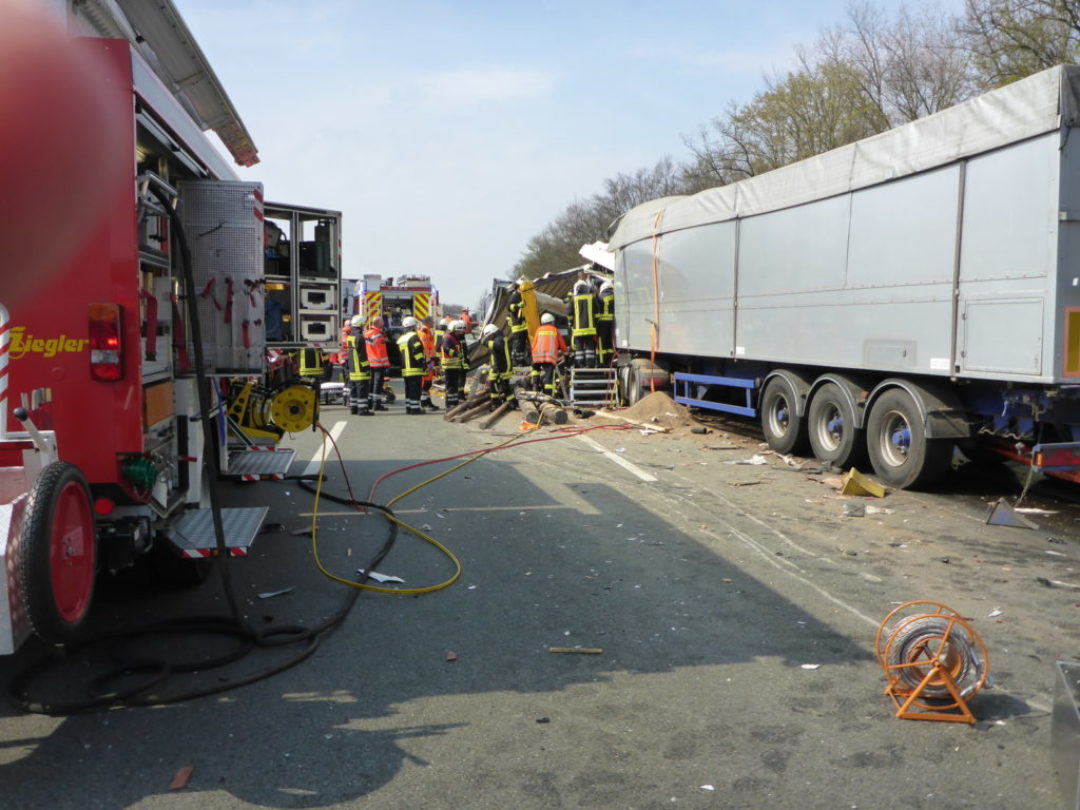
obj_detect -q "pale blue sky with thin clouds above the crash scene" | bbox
[174,0,959,306]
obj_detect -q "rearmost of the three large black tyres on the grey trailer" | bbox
[866,388,954,489]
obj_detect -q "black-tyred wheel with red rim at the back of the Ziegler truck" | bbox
[18,461,97,644]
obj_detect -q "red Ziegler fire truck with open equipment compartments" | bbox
[0,9,341,653]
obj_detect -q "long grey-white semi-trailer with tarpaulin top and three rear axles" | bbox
[610,67,1080,487]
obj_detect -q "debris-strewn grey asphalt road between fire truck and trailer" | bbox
[0,382,1080,810]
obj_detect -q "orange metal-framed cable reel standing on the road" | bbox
[874,600,989,724]
